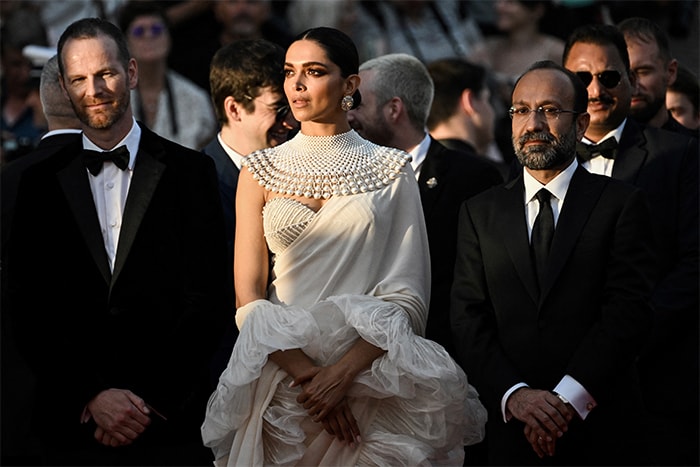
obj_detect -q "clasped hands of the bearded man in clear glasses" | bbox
[506,387,574,458]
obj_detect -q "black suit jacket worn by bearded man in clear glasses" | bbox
[452,167,655,465]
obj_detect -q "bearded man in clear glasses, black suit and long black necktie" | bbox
[451,61,654,465]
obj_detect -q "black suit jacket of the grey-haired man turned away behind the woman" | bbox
[418,139,503,353]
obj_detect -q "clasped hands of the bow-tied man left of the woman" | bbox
[87,389,151,447]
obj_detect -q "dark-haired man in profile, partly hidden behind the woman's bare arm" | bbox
[202,39,298,387]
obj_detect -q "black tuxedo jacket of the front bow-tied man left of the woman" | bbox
[9,127,231,464]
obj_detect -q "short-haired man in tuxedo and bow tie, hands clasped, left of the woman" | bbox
[8,18,231,465]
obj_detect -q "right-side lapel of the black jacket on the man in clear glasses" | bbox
[540,166,605,305]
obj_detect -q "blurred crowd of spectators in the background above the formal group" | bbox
[0,0,698,163]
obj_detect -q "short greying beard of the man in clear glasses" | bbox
[513,128,576,170]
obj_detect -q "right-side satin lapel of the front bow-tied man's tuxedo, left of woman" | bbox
[110,148,165,289]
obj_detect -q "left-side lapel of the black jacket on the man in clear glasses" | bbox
[497,175,539,303]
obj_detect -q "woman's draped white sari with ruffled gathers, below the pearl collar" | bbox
[202,133,486,466]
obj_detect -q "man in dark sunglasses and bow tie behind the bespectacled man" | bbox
[562,25,700,465]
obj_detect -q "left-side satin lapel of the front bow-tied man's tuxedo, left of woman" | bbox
[57,157,112,283]
